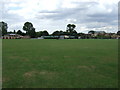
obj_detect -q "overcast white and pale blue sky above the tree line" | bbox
[0,0,119,33]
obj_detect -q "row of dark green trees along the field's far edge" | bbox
[0,21,120,38]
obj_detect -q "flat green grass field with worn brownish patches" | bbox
[2,39,118,88]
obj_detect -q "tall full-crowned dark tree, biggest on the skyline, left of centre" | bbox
[23,22,36,38]
